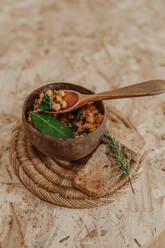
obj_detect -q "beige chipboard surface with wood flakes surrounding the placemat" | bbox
[0,0,165,248]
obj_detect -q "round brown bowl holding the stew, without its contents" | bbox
[22,82,106,161]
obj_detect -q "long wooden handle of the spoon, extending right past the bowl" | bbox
[85,80,165,101]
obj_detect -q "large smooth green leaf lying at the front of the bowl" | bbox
[30,112,74,138]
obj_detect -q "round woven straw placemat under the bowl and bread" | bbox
[10,105,142,208]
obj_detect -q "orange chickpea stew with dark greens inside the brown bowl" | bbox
[28,90,103,138]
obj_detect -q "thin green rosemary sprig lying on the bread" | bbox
[105,129,135,194]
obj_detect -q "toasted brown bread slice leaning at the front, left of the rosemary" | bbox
[74,144,119,197]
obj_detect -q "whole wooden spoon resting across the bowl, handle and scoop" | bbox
[45,80,165,114]
